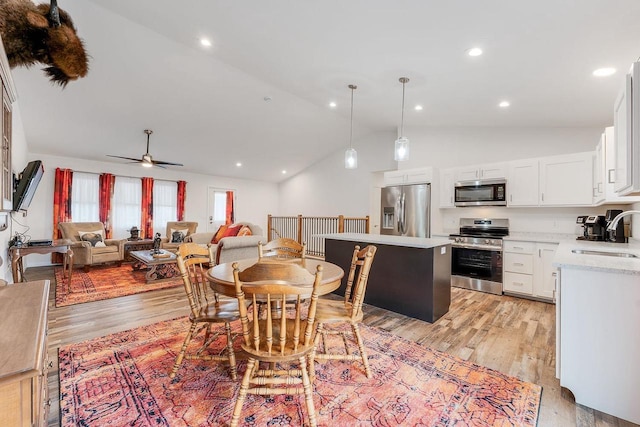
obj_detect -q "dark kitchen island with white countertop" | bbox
[319,233,451,322]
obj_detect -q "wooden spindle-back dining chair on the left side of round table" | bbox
[169,243,240,380]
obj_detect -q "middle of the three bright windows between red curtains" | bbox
[112,176,142,239]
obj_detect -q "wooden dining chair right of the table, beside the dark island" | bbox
[311,245,377,378]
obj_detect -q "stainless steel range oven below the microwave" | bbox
[449,218,509,295]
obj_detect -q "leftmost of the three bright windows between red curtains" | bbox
[71,172,100,222]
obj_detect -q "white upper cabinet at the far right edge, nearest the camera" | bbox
[613,62,640,196]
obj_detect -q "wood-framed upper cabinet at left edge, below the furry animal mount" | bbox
[0,36,16,211]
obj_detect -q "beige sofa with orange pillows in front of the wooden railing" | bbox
[185,222,267,264]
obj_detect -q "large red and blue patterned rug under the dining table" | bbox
[59,318,542,427]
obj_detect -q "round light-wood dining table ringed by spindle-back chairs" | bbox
[207,258,344,298]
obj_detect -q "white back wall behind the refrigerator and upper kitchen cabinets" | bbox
[280,127,640,234]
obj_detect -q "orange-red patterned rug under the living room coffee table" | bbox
[55,264,182,307]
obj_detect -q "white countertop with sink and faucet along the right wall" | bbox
[553,240,640,275]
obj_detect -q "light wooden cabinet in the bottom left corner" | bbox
[0,280,49,427]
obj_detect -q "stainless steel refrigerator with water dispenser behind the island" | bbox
[380,184,431,237]
